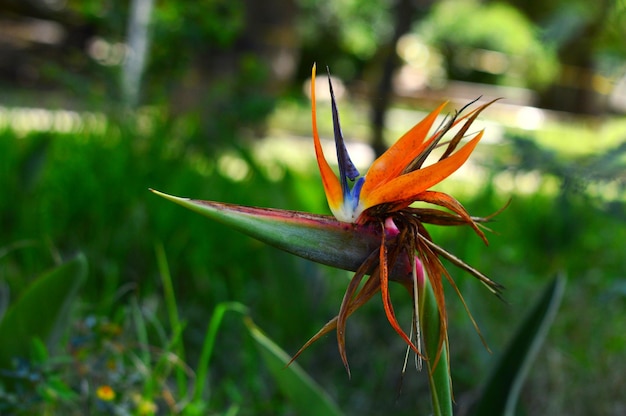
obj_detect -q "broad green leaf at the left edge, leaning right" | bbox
[0,254,87,368]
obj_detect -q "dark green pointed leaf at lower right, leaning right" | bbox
[472,276,566,416]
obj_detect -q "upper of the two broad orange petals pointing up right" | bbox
[361,101,448,195]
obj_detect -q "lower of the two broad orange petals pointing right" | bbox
[361,131,483,210]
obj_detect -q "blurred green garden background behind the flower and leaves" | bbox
[0,0,626,415]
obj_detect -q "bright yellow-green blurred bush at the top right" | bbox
[417,0,558,88]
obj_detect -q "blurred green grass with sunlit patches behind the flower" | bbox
[0,103,626,415]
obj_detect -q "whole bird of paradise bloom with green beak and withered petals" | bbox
[152,65,503,380]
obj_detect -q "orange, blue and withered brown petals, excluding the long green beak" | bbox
[303,66,501,371]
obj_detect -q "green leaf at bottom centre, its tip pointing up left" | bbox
[245,318,343,416]
